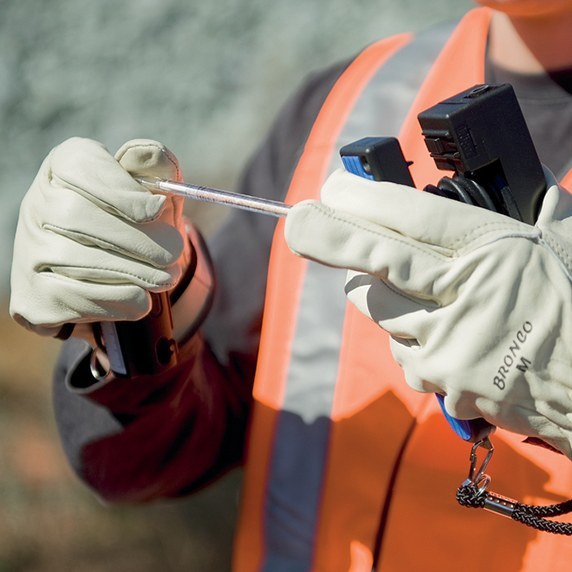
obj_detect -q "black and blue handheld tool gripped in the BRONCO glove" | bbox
[340,84,546,442]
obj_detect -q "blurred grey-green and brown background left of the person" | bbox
[0,0,473,572]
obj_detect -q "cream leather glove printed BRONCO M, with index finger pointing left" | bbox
[286,171,572,458]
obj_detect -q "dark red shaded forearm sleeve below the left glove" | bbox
[55,336,254,502]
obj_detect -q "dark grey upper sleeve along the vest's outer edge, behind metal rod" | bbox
[203,62,349,363]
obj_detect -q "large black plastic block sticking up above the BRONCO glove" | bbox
[418,84,546,224]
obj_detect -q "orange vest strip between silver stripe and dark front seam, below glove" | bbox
[315,307,426,572]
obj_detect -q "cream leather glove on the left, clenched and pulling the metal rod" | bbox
[10,138,190,336]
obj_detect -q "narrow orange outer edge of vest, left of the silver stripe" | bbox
[233,34,410,572]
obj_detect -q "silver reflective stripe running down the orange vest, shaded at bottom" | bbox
[263,20,453,572]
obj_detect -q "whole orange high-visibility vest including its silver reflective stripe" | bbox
[234,8,572,572]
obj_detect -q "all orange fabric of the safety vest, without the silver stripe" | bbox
[234,9,572,572]
